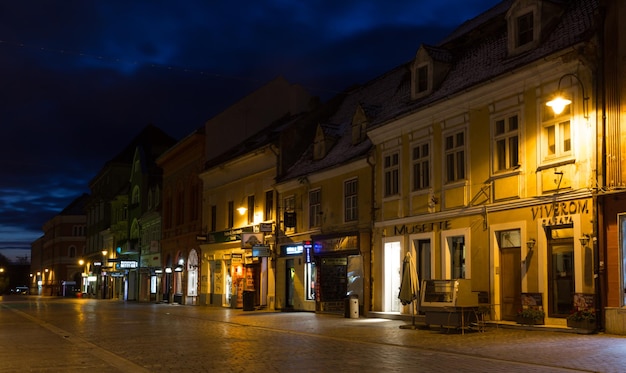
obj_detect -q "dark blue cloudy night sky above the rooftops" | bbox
[0,0,500,260]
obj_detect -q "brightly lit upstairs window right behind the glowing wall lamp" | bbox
[541,105,572,160]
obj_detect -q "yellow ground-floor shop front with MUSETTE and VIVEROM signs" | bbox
[374,194,595,326]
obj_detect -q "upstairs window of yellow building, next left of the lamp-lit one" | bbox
[493,114,519,172]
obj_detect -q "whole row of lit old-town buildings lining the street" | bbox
[32,0,626,334]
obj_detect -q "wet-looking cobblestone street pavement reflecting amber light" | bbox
[0,296,626,372]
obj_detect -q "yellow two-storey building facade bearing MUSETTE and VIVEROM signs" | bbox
[368,2,598,325]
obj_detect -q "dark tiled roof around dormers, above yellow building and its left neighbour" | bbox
[279,0,599,181]
